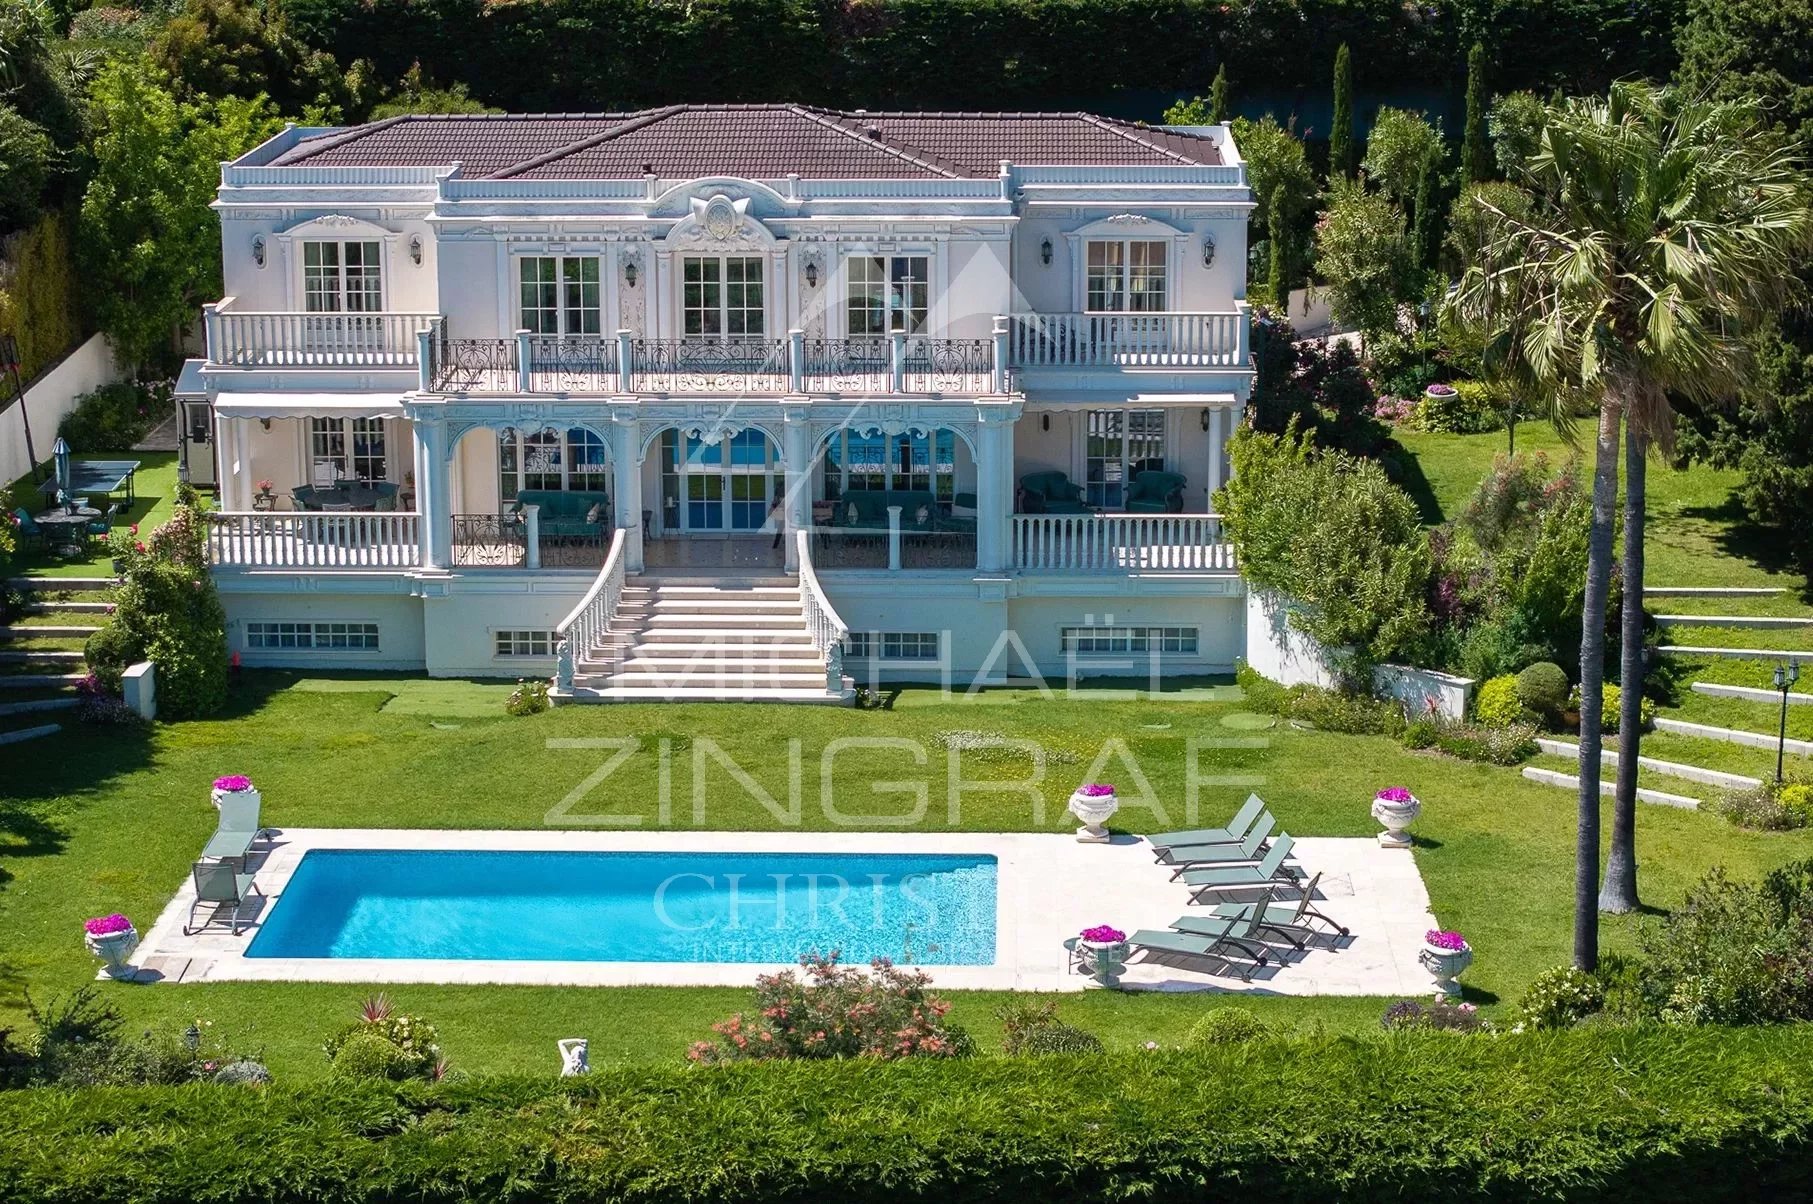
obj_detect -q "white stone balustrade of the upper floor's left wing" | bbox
[203,297,439,368]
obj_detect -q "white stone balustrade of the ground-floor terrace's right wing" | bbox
[1013,515,1235,573]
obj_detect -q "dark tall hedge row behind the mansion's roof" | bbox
[283,0,1681,115]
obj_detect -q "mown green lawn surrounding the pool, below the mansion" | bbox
[0,673,1813,1075]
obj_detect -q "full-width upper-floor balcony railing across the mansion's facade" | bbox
[205,297,1251,397]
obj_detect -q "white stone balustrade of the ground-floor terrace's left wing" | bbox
[208,511,421,569]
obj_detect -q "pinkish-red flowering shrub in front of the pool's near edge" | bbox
[687,952,974,1066]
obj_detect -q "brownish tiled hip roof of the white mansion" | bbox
[259,105,1220,180]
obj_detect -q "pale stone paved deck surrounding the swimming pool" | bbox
[132,829,1436,997]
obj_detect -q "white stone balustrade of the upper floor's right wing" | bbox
[1008,310,1249,368]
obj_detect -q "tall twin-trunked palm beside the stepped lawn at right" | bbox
[1450,83,1813,970]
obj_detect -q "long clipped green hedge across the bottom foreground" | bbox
[0,1026,1813,1204]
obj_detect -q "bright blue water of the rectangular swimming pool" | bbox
[247,849,995,965]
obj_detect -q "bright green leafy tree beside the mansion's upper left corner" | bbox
[78,62,277,364]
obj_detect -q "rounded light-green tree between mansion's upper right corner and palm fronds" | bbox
[1316,180,1416,337]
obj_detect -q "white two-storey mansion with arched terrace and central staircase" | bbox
[179,105,1253,700]
